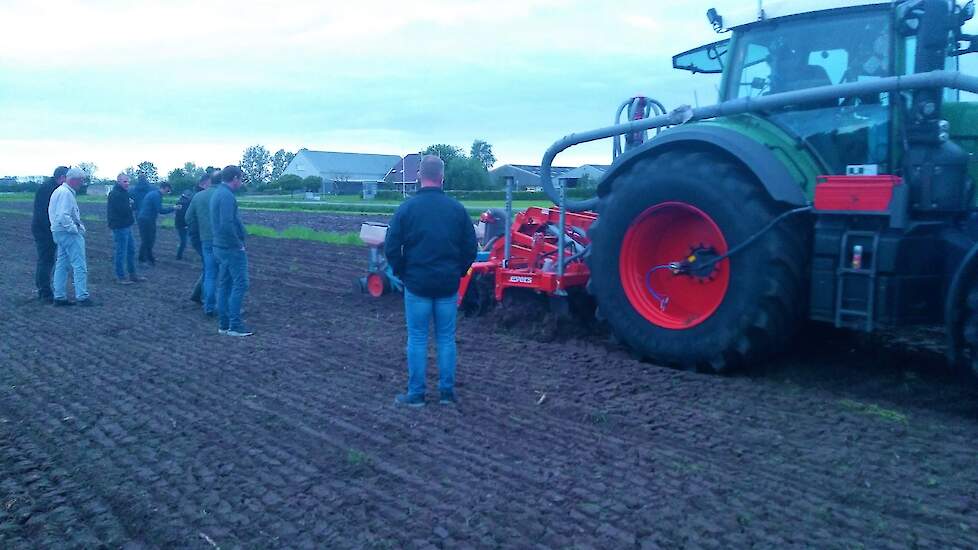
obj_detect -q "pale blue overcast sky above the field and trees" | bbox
[0,0,748,177]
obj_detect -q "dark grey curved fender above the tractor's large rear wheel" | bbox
[598,125,807,206]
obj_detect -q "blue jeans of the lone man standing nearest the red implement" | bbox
[404,288,458,397]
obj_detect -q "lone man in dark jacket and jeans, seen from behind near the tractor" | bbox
[384,155,476,407]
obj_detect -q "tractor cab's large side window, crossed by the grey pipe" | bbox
[724,7,893,174]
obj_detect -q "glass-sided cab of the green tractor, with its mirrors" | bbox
[673,0,973,174]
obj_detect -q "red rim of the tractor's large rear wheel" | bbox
[618,202,730,330]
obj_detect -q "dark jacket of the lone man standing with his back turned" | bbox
[384,187,476,298]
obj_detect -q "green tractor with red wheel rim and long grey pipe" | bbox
[541,0,978,372]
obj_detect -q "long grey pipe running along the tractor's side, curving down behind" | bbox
[540,71,978,212]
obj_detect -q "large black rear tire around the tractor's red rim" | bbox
[587,150,812,373]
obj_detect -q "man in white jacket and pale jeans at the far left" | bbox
[48,168,92,306]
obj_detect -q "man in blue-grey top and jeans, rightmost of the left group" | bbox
[209,165,254,336]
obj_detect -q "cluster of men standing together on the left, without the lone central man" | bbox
[31,165,253,337]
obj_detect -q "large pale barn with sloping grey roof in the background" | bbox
[284,148,402,194]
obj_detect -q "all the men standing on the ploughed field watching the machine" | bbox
[32,155,477,407]
